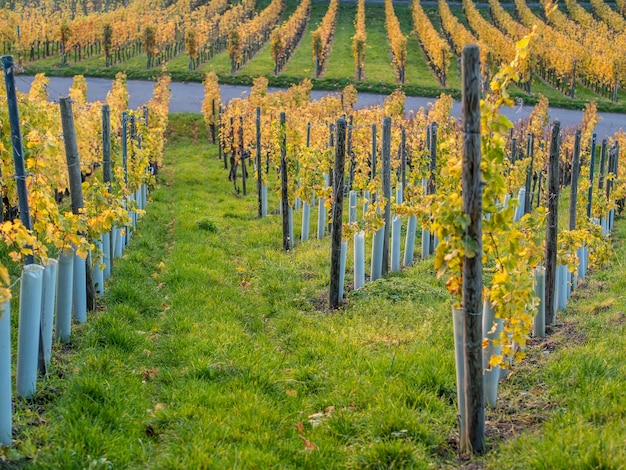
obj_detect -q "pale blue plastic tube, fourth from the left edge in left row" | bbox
[54,248,74,343]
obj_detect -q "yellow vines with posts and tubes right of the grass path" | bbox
[213,39,626,453]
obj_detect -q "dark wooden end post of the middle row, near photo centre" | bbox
[329,118,346,310]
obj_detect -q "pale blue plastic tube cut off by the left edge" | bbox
[0,302,13,446]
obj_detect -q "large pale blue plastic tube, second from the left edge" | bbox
[16,264,44,398]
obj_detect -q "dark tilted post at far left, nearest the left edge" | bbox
[2,56,35,265]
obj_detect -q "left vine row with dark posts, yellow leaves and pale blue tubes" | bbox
[0,60,169,446]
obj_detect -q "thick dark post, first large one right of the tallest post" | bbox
[545,121,561,325]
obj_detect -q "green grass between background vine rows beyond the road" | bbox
[17,0,626,112]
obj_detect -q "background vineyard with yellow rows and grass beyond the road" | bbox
[0,0,626,111]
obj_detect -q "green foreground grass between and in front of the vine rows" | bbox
[0,115,626,469]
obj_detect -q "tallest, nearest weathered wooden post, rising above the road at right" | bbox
[461,45,485,453]
